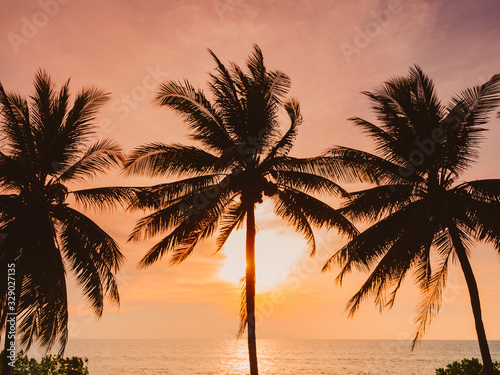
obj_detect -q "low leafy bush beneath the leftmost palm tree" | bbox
[0,351,89,375]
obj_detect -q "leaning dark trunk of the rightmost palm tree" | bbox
[450,226,493,375]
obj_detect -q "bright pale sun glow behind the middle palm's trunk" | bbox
[219,229,307,293]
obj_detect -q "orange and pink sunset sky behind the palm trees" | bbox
[0,0,500,339]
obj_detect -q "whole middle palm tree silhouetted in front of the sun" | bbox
[125,46,356,375]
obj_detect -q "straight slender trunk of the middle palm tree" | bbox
[245,203,259,375]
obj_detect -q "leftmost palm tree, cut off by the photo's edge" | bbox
[0,70,131,374]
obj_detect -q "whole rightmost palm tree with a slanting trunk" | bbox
[324,66,500,374]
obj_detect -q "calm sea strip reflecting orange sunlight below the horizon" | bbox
[59,340,500,375]
